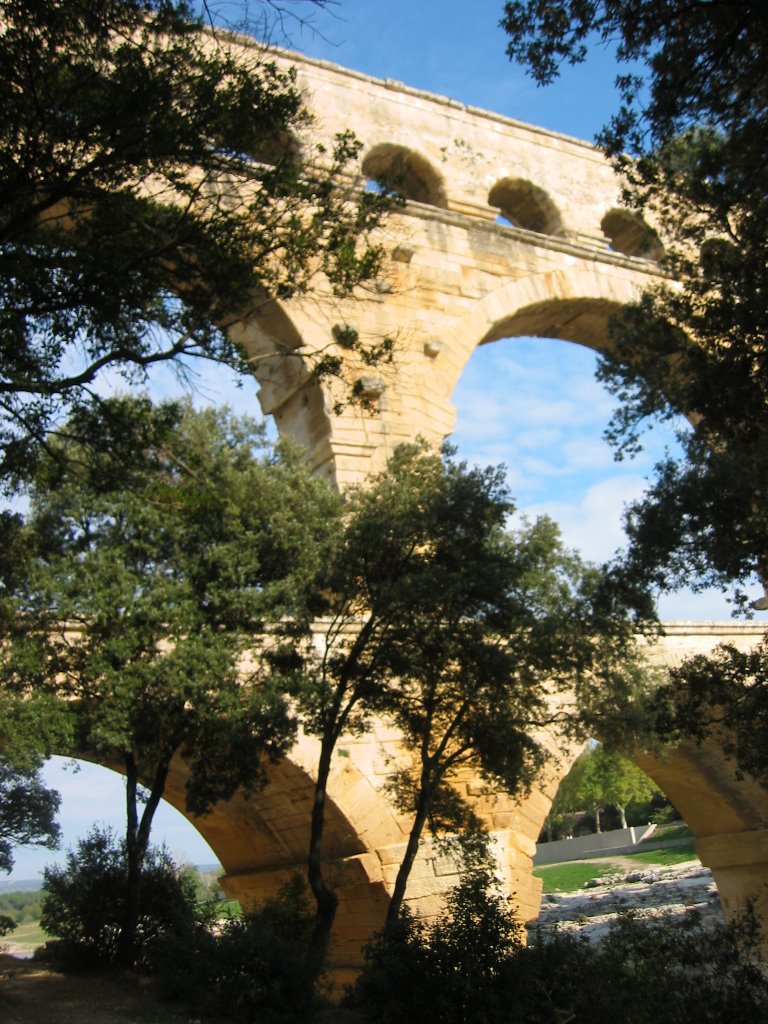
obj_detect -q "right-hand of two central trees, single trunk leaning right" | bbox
[378,516,651,925]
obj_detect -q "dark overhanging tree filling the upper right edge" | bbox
[502,0,768,608]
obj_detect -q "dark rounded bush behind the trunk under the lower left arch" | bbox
[40,827,196,967]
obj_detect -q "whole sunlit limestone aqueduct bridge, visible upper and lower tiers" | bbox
[137,48,768,967]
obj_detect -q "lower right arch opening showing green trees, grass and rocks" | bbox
[534,741,723,937]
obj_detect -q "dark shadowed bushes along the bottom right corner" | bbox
[349,878,768,1024]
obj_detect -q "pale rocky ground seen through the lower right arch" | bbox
[529,857,722,939]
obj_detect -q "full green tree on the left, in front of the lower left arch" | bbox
[6,399,338,963]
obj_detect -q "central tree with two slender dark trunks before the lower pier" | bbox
[282,445,651,958]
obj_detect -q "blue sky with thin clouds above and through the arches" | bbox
[10,0,753,879]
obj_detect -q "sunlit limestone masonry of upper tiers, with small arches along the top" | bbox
[221,41,659,486]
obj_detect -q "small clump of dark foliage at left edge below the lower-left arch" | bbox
[0,758,61,871]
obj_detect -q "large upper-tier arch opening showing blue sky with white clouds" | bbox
[451,329,730,621]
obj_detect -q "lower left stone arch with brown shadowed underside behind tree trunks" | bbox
[67,728,415,984]
